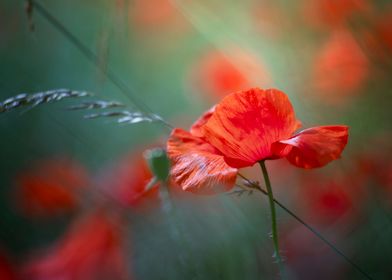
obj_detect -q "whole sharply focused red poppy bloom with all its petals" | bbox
[167,88,348,191]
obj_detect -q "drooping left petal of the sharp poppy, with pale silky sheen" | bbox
[167,129,237,194]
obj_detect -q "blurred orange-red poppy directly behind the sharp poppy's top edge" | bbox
[191,49,270,98]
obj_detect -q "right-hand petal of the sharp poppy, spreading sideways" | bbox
[273,125,348,168]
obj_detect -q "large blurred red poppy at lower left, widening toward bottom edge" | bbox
[22,211,129,280]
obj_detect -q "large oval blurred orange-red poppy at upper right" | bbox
[313,30,369,103]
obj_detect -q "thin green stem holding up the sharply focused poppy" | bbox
[259,160,284,277]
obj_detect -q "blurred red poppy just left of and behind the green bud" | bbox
[97,152,159,208]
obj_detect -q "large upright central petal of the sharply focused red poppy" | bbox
[203,88,299,168]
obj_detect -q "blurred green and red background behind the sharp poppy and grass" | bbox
[0,0,392,280]
